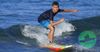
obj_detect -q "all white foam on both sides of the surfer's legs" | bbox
[22,22,75,45]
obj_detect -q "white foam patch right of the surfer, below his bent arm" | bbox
[55,21,75,36]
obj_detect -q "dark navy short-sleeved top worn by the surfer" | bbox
[38,9,64,22]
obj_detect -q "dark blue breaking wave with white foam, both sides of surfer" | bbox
[0,17,100,52]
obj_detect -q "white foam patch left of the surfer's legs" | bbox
[22,25,48,45]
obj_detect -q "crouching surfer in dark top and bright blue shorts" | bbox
[38,1,78,43]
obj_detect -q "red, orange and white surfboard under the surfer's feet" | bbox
[40,44,73,52]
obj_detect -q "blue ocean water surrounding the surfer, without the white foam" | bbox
[0,0,100,52]
